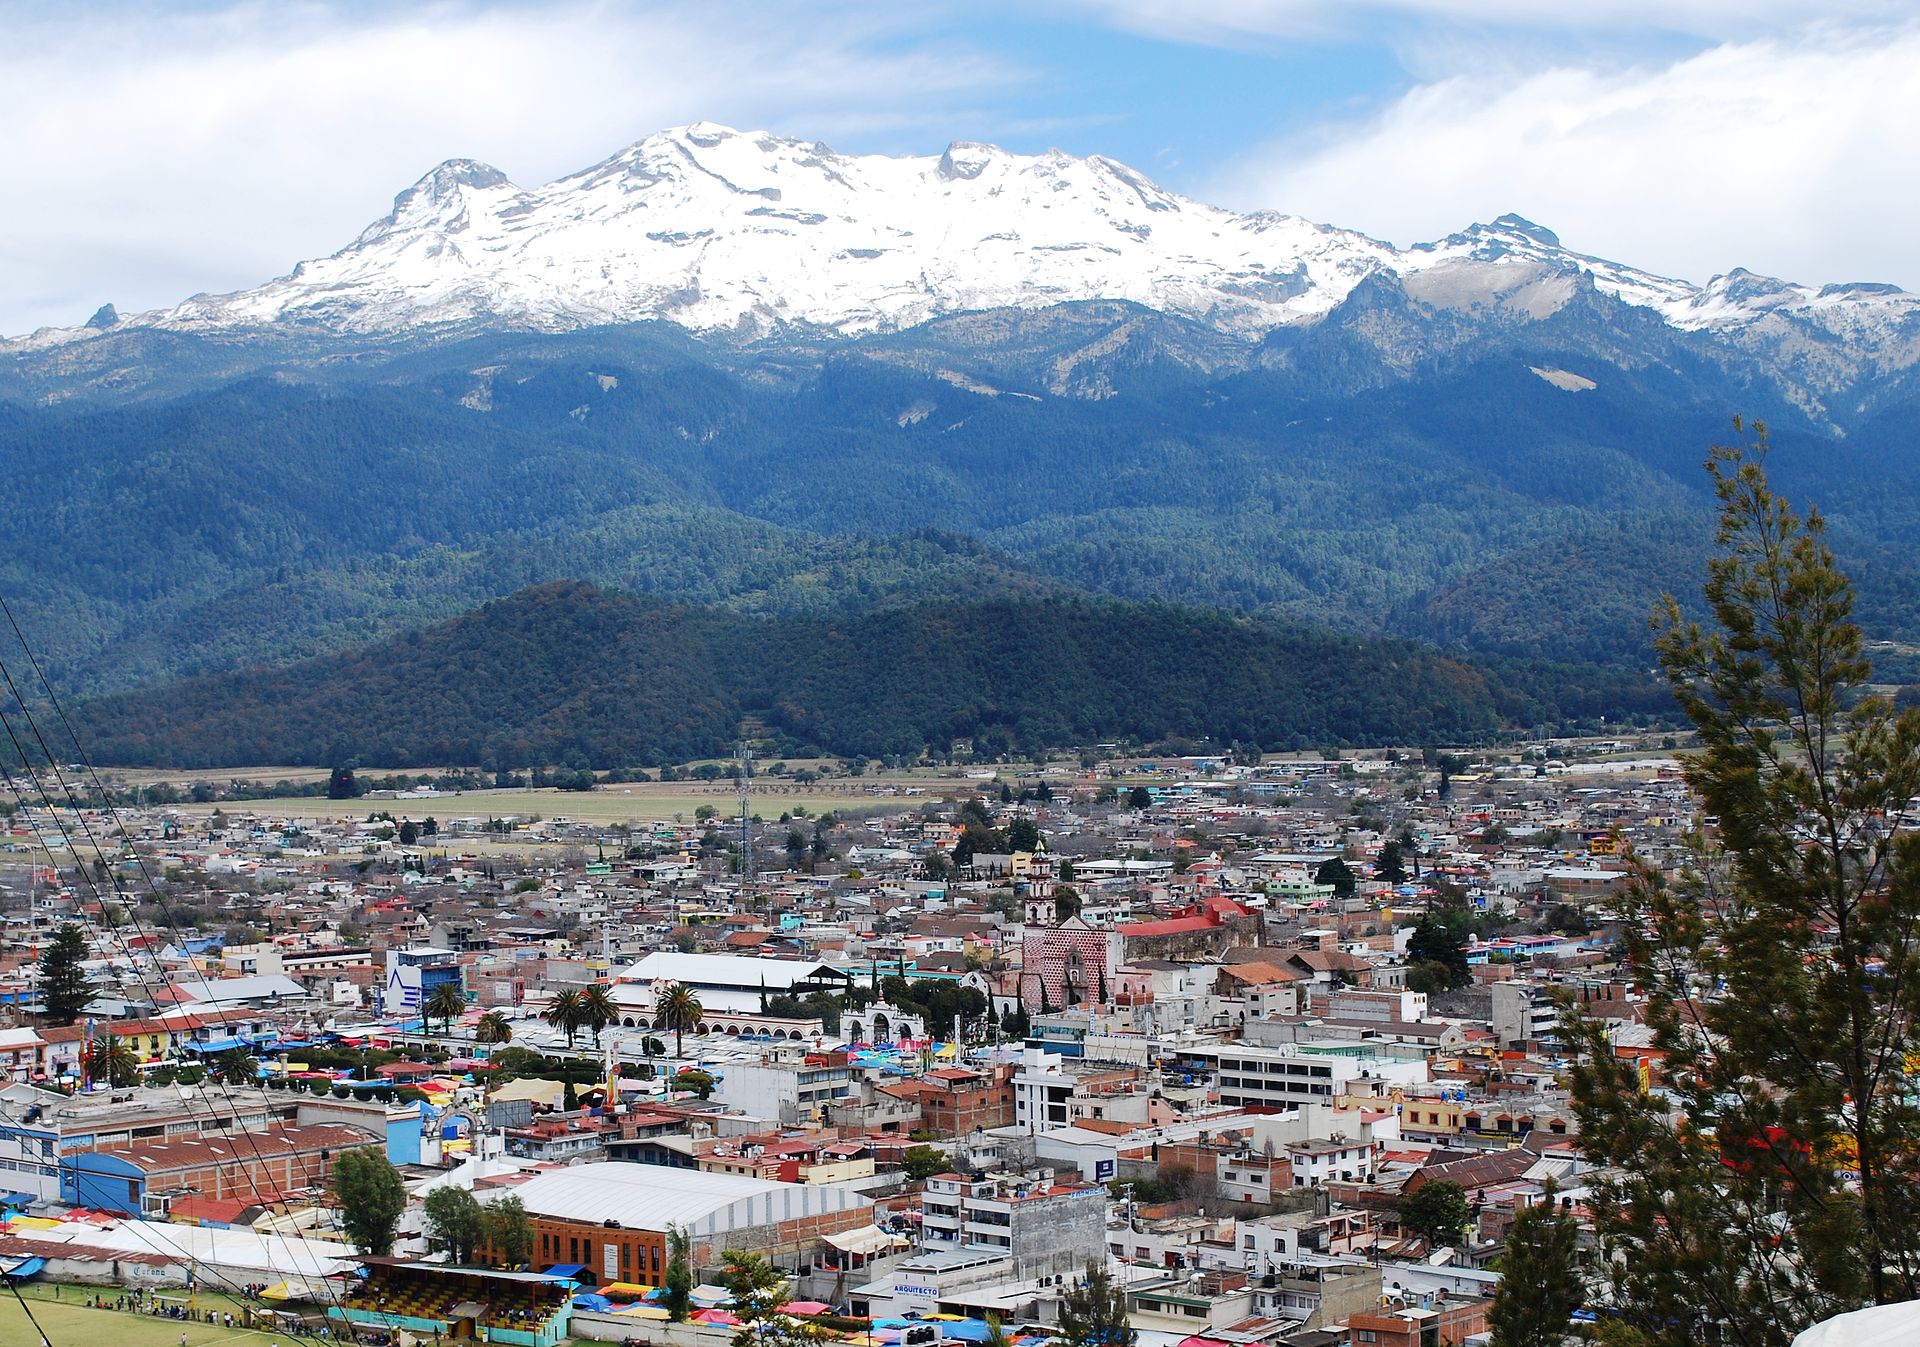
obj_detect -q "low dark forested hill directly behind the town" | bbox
[79,581,1655,768]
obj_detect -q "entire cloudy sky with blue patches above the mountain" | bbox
[0,0,1920,334]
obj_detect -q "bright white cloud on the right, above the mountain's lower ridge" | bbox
[1213,27,1920,288]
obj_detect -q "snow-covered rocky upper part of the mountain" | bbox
[18,123,1920,368]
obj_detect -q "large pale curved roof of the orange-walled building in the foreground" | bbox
[511,1161,872,1236]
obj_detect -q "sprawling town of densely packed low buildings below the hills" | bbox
[0,735,1701,1347]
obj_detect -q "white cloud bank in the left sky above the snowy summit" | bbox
[0,0,1014,332]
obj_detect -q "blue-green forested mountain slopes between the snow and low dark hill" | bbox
[0,297,1920,714]
